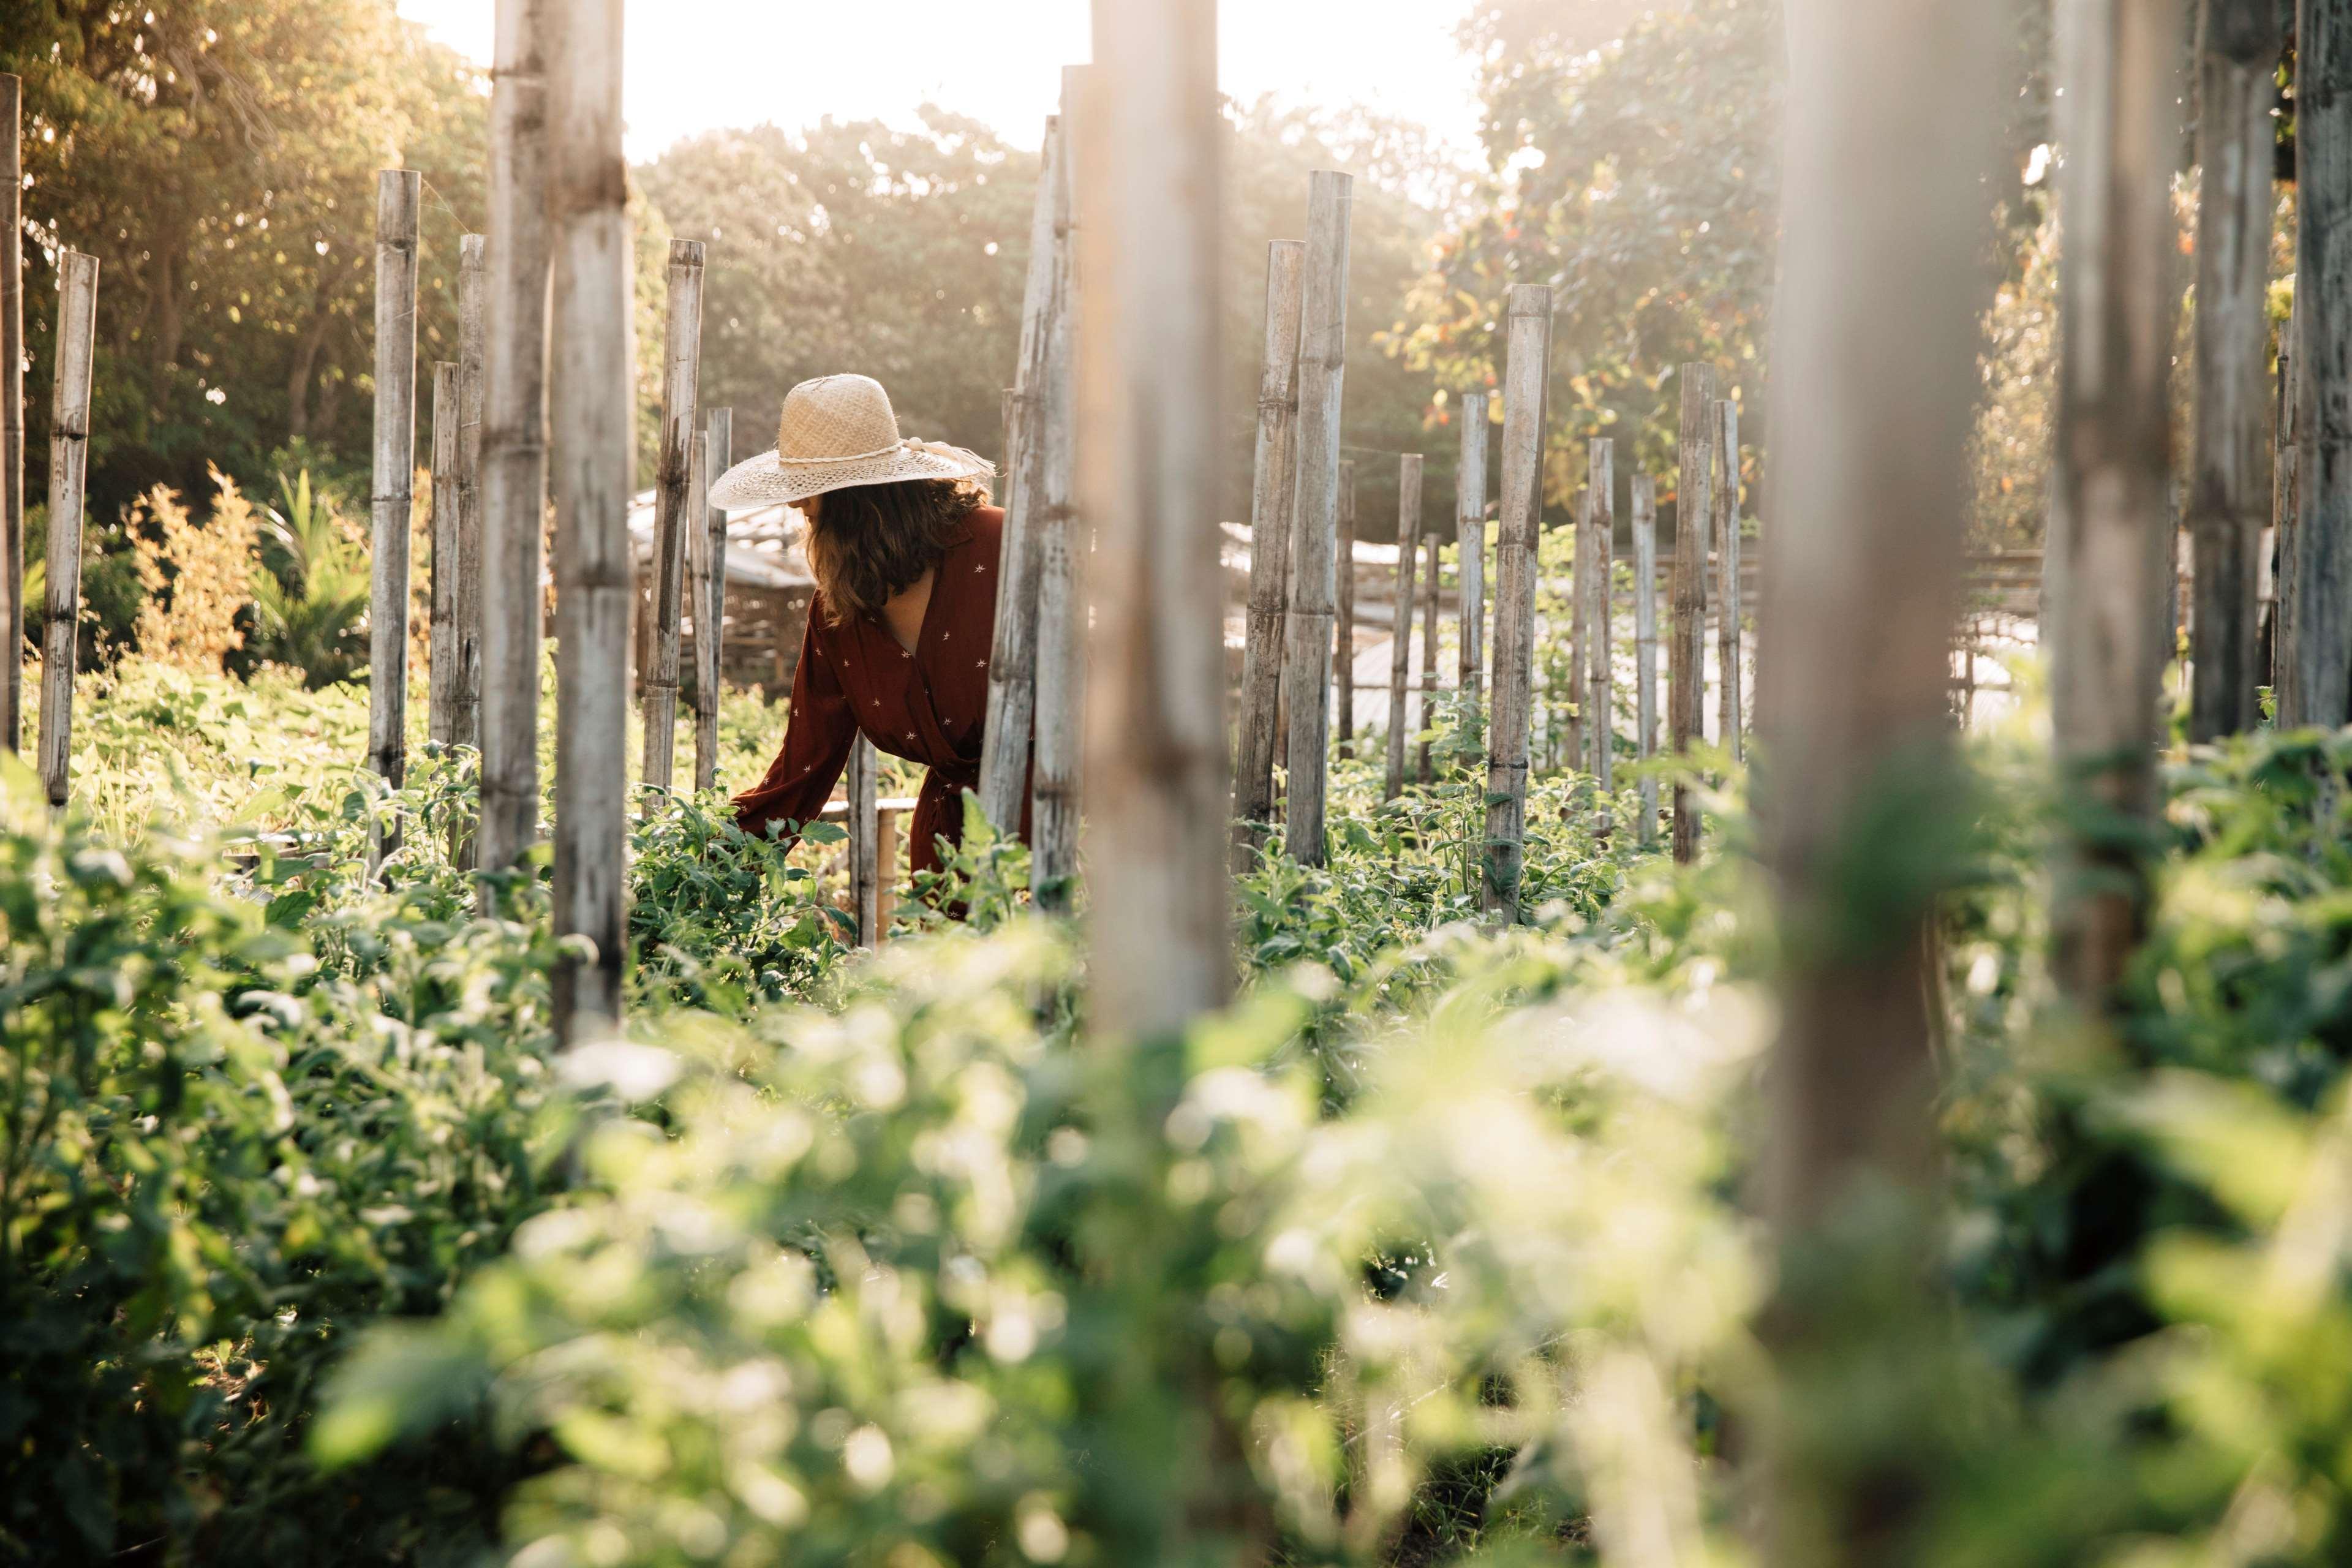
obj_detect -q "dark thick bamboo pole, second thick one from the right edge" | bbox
[2190,0,2282,741]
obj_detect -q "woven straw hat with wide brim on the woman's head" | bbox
[710,376,995,510]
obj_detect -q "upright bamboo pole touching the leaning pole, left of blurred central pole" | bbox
[1030,66,1094,912]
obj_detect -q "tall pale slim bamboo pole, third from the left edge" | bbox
[367,169,423,853]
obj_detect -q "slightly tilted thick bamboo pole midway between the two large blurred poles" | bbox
[1484,282,1552,924]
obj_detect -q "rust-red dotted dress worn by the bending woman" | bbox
[734,505,1030,875]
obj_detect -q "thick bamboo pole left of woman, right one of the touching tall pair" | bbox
[548,0,635,1044]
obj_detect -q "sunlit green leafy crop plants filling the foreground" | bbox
[13,673,2352,1568]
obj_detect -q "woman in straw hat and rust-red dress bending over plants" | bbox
[710,376,1028,875]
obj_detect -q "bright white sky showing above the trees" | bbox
[400,0,1477,160]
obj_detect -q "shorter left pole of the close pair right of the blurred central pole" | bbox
[1232,239,1308,832]
